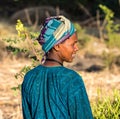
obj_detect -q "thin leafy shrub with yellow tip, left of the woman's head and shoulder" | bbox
[6,20,43,91]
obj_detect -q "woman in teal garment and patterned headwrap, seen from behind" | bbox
[22,15,93,119]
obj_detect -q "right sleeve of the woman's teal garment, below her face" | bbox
[68,72,93,119]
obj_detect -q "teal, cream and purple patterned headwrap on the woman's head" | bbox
[37,16,75,53]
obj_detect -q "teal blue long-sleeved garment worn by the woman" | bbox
[22,65,93,119]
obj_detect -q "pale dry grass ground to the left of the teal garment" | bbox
[0,59,30,119]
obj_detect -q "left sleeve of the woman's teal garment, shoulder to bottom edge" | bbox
[21,70,39,119]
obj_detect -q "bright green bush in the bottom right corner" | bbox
[92,90,120,119]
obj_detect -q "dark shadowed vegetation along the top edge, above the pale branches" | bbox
[0,0,120,20]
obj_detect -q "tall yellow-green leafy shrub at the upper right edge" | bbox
[99,4,120,48]
